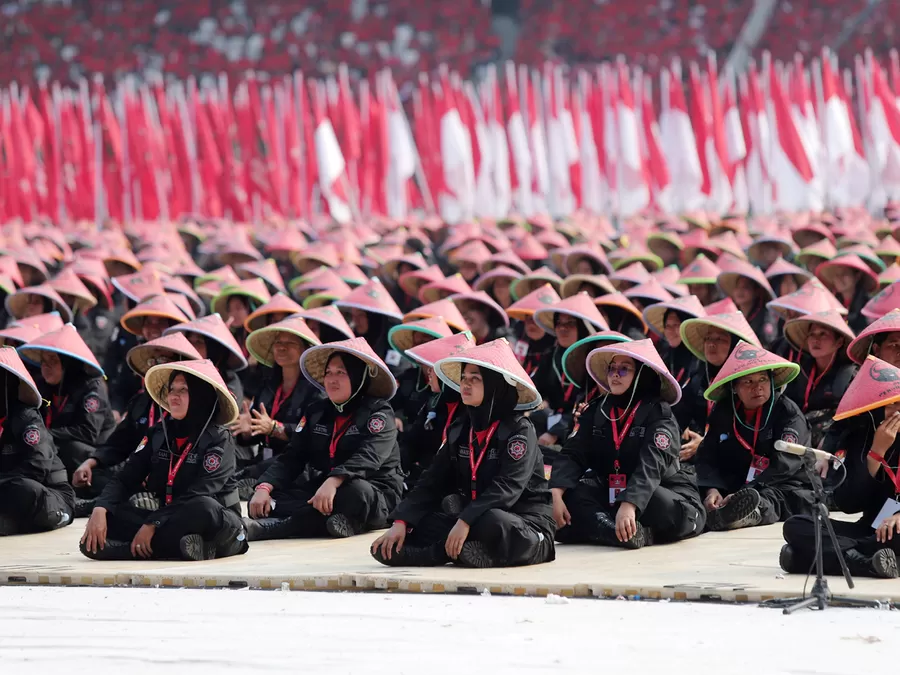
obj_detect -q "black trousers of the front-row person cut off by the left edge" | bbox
[0,476,75,533]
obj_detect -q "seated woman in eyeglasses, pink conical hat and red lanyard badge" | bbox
[550,340,705,549]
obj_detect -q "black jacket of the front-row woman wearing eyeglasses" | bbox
[550,398,701,513]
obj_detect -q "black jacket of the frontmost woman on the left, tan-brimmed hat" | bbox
[96,424,235,527]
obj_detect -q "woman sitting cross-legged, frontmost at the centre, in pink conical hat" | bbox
[371,340,556,567]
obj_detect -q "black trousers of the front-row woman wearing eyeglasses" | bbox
[556,482,706,544]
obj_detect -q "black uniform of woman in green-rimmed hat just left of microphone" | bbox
[696,394,812,529]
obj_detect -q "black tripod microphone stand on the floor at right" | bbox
[760,461,881,614]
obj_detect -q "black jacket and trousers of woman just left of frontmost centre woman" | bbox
[249,396,403,541]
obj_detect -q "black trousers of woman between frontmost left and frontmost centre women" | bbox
[270,478,390,537]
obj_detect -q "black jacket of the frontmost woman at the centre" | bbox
[391,415,556,538]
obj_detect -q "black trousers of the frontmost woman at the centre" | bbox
[405,509,556,567]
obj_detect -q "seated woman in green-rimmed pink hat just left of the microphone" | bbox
[696,342,812,531]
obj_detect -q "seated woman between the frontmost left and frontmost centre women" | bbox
[245,338,403,541]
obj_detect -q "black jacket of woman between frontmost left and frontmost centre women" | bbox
[257,396,403,509]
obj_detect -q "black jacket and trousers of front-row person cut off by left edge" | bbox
[0,401,75,535]
